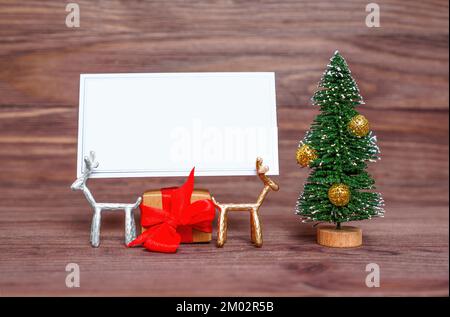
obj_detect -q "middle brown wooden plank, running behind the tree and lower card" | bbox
[0,107,448,207]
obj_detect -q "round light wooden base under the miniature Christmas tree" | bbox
[317,226,362,248]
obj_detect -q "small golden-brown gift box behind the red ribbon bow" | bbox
[141,188,212,243]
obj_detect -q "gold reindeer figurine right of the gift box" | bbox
[212,157,279,248]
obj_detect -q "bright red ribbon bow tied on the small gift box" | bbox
[128,168,215,253]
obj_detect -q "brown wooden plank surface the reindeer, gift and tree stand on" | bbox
[0,204,448,296]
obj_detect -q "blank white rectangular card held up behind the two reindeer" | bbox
[77,73,278,177]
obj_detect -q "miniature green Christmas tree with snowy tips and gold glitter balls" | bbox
[296,51,384,242]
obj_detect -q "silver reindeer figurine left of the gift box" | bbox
[70,152,142,248]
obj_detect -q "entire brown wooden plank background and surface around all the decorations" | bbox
[0,0,449,296]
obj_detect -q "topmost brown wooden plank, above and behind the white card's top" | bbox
[0,1,448,109]
